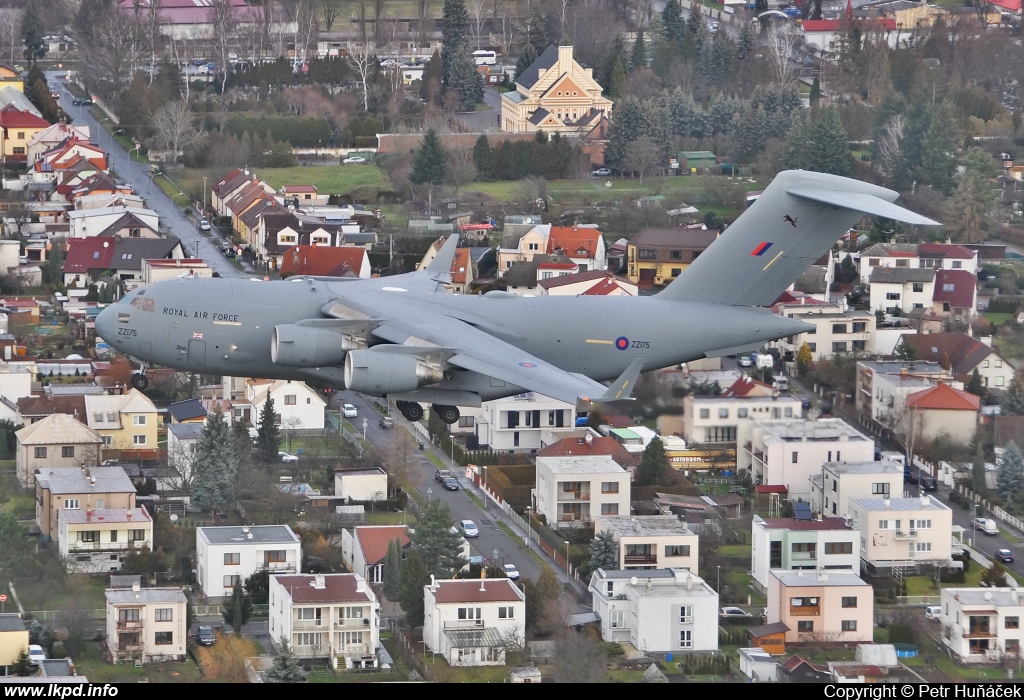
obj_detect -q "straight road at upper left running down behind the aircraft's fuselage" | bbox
[46,71,252,277]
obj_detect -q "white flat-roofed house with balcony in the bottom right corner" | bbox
[939,586,1024,663]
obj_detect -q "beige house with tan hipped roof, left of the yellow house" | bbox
[14,413,102,488]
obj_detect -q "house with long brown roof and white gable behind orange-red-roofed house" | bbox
[900,333,1014,390]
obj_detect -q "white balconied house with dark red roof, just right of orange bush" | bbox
[269,574,380,670]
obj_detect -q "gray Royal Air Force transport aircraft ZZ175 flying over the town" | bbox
[96,171,937,424]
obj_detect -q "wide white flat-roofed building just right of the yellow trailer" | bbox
[736,419,874,498]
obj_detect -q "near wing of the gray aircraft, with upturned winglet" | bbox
[348,304,643,404]
